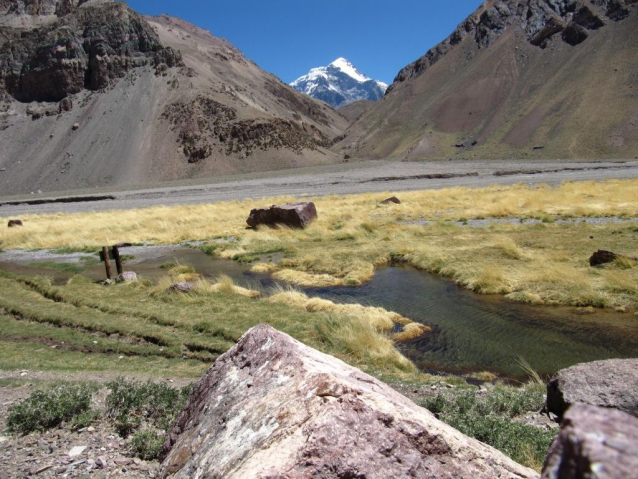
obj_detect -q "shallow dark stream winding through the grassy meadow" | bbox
[0,246,638,378]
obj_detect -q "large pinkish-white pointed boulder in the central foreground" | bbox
[159,325,538,479]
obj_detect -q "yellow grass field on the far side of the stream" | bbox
[0,180,638,309]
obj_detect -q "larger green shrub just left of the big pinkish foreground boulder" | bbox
[106,378,190,436]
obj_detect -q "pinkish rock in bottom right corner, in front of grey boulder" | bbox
[542,404,638,479]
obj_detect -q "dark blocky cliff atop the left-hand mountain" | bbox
[0,0,181,102]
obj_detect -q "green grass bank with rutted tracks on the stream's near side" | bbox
[0,272,413,376]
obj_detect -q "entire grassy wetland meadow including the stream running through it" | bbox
[0,180,638,469]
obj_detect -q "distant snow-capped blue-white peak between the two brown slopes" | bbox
[290,58,388,108]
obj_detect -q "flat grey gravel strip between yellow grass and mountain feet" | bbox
[0,160,638,218]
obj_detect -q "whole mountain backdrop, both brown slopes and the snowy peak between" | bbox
[0,0,638,196]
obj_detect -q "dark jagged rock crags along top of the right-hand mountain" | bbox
[390,0,638,90]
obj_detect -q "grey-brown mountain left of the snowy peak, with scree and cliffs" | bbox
[0,0,348,195]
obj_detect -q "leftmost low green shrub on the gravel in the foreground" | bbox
[7,385,93,434]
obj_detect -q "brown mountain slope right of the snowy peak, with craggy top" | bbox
[335,0,638,159]
